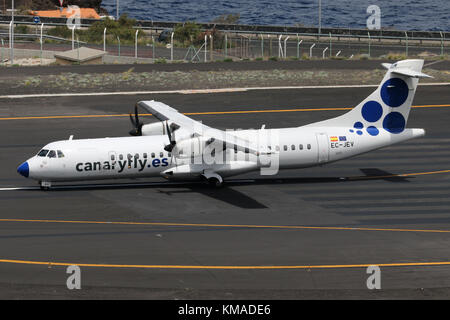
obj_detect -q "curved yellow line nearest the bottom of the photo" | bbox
[0,259,450,270]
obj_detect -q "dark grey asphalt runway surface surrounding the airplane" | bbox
[0,86,450,299]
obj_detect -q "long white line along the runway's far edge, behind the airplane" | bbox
[0,82,450,99]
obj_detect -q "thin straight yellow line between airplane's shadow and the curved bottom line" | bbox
[0,219,450,233]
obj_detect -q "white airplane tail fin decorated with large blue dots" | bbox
[308,60,430,135]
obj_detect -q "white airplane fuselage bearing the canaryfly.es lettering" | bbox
[22,127,424,182]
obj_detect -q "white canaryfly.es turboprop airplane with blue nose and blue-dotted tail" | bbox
[17,60,429,189]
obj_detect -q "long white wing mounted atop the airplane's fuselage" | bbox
[138,100,259,155]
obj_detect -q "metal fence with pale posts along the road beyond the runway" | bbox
[0,21,450,63]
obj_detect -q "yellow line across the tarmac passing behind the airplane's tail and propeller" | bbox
[0,104,450,120]
